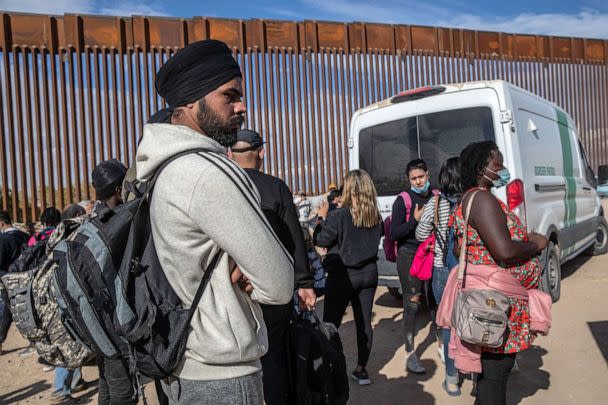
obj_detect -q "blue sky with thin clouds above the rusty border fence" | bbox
[0,0,608,39]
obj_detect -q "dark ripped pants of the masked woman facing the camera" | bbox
[397,246,424,353]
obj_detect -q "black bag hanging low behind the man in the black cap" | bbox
[289,311,349,405]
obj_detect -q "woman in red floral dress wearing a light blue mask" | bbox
[453,141,547,405]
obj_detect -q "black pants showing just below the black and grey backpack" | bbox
[97,356,137,405]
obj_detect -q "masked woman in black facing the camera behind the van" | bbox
[391,159,432,374]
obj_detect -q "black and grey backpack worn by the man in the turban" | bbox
[55,149,219,378]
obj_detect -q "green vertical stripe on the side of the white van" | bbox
[555,109,576,254]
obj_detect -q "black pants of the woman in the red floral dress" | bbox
[475,353,515,405]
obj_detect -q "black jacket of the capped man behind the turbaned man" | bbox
[245,169,315,289]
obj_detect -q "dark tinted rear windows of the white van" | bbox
[359,107,495,196]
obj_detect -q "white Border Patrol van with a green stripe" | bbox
[348,80,608,300]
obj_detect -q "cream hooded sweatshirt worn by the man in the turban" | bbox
[136,124,294,380]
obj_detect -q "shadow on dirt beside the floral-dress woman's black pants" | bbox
[507,346,551,405]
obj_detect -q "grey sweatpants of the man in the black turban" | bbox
[162,372,264,405]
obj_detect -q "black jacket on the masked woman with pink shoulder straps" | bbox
[391,190,433,250]
